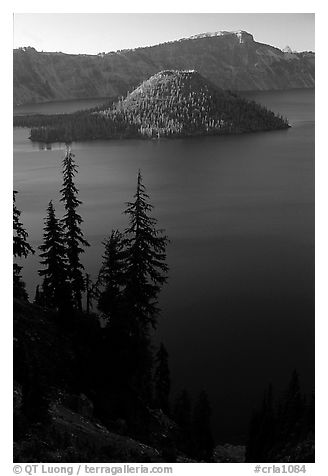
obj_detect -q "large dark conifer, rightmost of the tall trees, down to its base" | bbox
[123,171,168,401]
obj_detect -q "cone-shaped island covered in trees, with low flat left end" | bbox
[14,70,289,142]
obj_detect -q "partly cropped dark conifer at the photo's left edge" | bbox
[13,190,34,299]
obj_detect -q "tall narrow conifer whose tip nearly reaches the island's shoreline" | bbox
[60,146,89,310]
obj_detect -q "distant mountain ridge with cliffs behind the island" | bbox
[14,31,315,105]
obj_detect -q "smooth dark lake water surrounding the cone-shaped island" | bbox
[14,90,314,443]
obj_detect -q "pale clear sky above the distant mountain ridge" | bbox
[14,13,315,54]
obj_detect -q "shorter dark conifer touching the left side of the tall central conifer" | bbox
[98,230,125,324]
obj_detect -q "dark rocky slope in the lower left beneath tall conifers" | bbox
[14,300,191,463]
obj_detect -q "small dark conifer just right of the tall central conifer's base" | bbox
[154,344,171,415]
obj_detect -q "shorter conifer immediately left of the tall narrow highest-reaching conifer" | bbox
[39,201,70,309]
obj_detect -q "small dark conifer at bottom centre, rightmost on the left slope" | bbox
[192,391,214,461]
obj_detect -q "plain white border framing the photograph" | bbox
[0,0,328,476]
